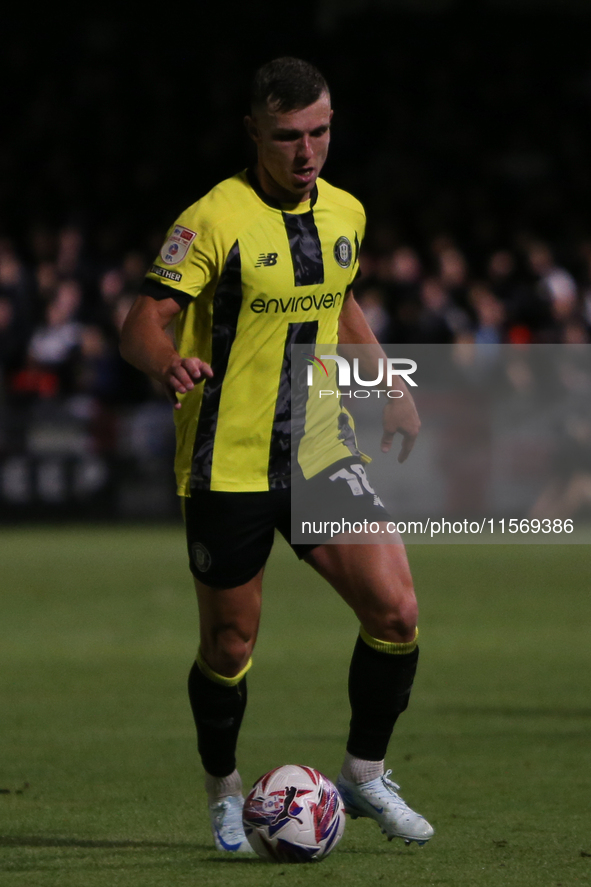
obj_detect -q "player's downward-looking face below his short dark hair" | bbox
[246,93,332,203]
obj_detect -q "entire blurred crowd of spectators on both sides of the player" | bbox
[0,226,591,405]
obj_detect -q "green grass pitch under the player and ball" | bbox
[0,526,591,887]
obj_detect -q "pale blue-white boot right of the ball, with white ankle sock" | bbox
[337,770,435,846]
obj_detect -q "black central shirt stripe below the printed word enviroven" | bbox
[268,320,318,490]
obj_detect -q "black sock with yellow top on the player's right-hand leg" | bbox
[347,628,419,775]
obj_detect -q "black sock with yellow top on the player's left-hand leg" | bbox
[189,651,252,780]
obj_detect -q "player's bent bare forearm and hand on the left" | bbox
[120,295,213,409]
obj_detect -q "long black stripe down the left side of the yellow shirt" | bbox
[191,241,242,490]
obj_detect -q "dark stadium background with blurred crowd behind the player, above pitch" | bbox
[0,0,591,519]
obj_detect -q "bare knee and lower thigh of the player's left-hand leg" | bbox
[195,568,264,676]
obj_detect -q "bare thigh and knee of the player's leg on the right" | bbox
[305,540,418,643]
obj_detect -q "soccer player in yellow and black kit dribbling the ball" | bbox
[121,58,433,851]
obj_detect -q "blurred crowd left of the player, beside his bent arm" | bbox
[0,227,155,405]
